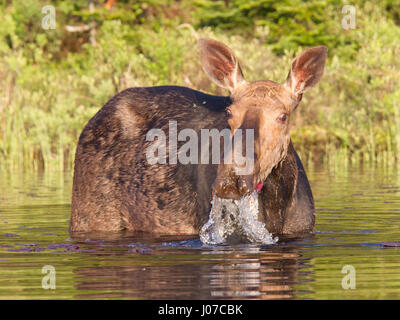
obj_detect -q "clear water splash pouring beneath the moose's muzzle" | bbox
[200,191,278,244]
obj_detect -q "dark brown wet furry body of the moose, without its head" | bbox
[70,87,314,234]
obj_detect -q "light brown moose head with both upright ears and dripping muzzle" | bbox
[199,39,327,200]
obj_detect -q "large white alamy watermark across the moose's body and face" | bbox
[146,121,254,175]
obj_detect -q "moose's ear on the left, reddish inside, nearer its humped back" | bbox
[199,38,246,93]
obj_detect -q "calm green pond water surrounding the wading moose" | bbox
[0,167,400,299]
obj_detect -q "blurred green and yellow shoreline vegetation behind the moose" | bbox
[0,0,400,170]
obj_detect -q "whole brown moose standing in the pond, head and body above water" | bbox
[70,38,327,241]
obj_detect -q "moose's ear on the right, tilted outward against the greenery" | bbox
[285,46,328,96]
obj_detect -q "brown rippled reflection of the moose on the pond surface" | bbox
[69,240,307,299]
